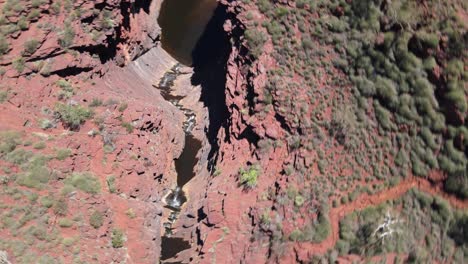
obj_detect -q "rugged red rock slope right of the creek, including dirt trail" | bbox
[176,0,468,263]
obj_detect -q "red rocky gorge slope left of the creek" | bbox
[0,0,190,263]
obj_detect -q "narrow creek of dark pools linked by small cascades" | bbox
[157,0,218,263]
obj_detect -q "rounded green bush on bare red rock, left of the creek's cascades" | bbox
[55,104,93,130]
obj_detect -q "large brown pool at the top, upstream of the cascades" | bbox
[158,0,218,66]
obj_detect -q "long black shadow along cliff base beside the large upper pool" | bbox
[192,4,238,169]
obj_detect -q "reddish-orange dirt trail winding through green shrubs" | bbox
[295,177,468,260]
